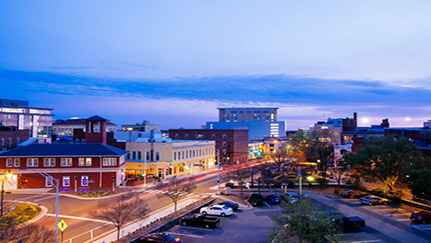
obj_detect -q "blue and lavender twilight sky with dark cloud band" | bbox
[0,0,431,130]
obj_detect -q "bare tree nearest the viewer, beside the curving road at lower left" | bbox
[92,191,148,240]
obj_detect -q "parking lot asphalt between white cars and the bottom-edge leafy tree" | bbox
[167,201,280,243]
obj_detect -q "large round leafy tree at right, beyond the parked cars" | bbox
[344,138,418,191]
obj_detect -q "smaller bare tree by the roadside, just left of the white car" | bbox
[156,177,196,212]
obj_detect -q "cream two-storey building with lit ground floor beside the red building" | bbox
[125,139,215,178]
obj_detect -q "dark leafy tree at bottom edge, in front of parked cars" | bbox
[269,199,342,243]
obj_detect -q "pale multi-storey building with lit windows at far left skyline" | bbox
[0,99,54,138]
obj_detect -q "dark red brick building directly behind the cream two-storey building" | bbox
[169,129,248,164]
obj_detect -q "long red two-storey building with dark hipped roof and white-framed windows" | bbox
[0,143,127,190]
